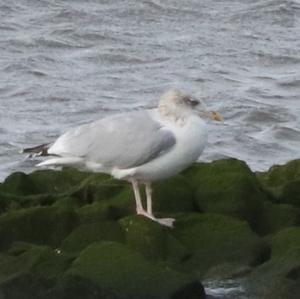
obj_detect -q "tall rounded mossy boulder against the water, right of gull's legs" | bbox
[185,159,267,231]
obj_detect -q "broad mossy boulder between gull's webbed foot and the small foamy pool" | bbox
[173,213,267,276]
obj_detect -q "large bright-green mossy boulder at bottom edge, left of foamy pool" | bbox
[67,242,205,299]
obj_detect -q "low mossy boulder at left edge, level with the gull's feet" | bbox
[0,207,79,250]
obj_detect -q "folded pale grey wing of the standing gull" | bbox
[49,111,176,169]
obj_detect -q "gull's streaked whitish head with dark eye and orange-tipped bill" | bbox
[158,89,223,121]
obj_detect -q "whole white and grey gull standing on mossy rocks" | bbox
[24,90,222,227]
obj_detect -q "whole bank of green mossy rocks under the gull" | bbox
[0,159,300,299]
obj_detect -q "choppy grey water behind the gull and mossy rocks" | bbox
[0,0,300,180]
